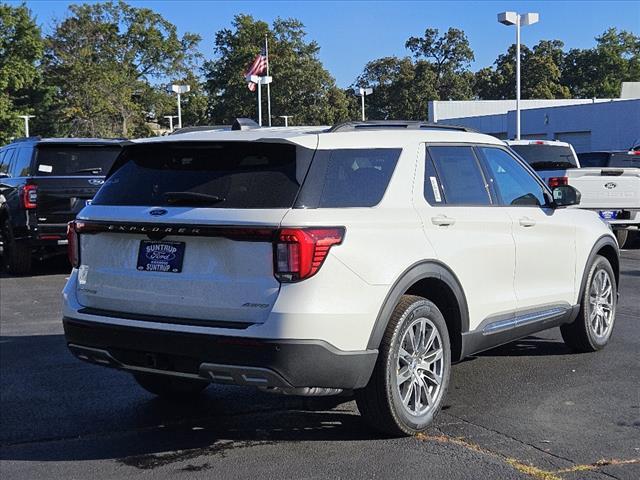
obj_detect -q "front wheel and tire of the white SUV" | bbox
[560,255,618,352]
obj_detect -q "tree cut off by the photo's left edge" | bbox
[0,4,44,145]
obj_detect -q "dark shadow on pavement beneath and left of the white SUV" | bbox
[0,328,569,469]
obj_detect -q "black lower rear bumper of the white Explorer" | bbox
[63,317,378,389]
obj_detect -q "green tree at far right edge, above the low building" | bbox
[562,28,640,98]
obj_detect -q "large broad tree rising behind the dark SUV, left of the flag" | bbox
[45,1,200,137]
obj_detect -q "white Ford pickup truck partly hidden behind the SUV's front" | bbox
[507,140,640,247]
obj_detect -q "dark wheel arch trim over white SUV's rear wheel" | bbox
[367,260,469,361]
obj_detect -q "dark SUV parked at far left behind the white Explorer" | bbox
[0,137,123,274]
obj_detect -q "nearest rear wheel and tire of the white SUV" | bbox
[355,295,451,436]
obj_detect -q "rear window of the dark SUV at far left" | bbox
[34,144,121,177]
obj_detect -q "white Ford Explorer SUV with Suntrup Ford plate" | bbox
[63,122,619,434]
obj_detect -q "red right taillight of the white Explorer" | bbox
[273,227,344,282]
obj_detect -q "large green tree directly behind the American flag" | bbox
[204,15,349,125]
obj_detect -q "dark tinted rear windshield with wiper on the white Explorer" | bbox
[93,142,310,208]
